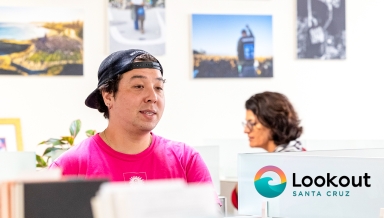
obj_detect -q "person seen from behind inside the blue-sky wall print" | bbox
[237,25,256,77]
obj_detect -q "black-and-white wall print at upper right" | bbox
[297,0,346,60]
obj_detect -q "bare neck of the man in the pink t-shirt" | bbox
[100,125,152,154]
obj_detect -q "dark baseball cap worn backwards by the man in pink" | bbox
[85,49,163,109]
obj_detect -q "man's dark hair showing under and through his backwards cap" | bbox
[96,53,158,119]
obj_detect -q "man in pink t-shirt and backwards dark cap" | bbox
[51,49,212,187]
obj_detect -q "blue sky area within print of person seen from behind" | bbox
[192,14,273,57]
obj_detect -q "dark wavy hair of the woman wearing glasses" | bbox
[245,92,303,146]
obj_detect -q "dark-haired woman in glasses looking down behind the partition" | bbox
[232,92,305,208]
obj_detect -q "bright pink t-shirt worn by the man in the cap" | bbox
[50,133,212,184]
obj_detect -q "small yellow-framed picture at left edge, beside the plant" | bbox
[0,118,23,151]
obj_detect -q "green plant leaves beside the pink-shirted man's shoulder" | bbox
[36,120,96,168]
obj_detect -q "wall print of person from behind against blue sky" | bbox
[192,14,273,78]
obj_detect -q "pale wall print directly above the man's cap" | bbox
[108,0,166,55]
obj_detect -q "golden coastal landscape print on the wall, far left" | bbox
[0,7,83,76]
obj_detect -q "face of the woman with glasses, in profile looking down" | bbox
[244,110,272,149]
